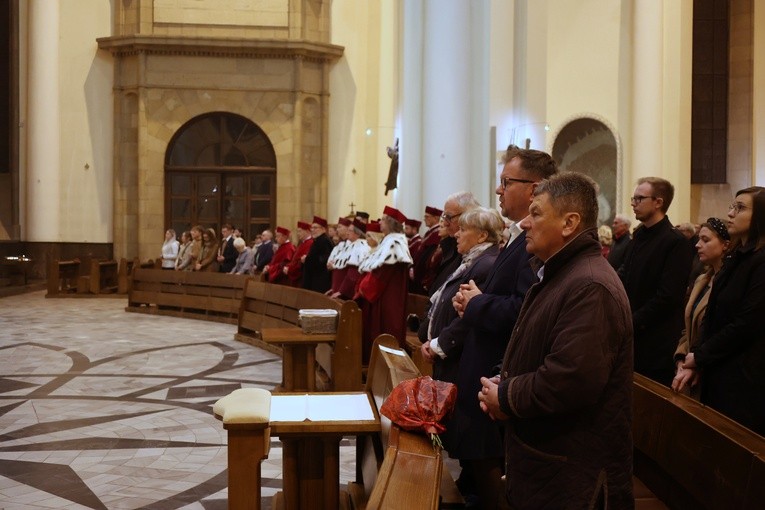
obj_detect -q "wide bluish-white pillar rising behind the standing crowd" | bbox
[397,0,493,214]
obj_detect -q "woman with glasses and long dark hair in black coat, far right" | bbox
[683,186,765,435]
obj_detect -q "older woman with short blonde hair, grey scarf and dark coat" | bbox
[420,207,504,509]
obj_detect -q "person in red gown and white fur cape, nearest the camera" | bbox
[354,206,412,364]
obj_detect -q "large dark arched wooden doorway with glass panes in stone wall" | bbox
[165,112,276,241]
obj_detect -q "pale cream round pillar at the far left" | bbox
[23,0,62,242]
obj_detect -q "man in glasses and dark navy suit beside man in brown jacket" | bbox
[423,146,558,508]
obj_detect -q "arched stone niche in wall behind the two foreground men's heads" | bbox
[552,116,622,225]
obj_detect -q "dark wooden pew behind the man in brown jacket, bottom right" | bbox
[632,374,765,509]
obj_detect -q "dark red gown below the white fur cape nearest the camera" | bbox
[359,263,409,365]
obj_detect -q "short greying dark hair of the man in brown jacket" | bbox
[534,172,598,230]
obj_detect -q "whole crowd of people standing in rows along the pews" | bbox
[162,147,765,509]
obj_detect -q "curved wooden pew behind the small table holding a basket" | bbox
[234,279,363,391]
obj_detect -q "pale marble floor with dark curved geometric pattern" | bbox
[0,292,362,510]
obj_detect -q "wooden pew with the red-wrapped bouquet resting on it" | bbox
[348,335,465,510]
